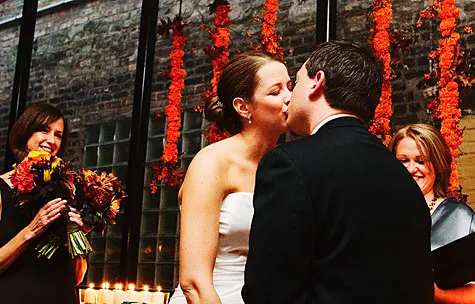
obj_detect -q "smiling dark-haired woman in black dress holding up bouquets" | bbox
[0,104,87,304]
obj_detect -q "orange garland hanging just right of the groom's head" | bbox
[369,0,392,145]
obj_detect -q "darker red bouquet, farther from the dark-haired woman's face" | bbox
[74,169,126,233]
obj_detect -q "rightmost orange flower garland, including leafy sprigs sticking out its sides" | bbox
[416,0,472,195]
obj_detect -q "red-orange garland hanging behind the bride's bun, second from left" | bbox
[203,0,231,144]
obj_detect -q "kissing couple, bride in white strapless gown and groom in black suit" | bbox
[170,40,433,304]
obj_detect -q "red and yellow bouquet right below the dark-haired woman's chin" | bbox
[10,151,91,259]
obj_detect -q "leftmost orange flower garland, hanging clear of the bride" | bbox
[150,16,187,193]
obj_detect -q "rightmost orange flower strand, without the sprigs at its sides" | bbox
[438,0,462,191]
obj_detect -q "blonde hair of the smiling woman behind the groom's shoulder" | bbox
[389,124,452,197]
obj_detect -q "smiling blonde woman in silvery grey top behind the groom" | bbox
[389,124,475,304]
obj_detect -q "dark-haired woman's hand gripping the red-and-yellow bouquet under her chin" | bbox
[26,198,67,239]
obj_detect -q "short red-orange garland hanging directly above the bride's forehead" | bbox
[261,0,284,59]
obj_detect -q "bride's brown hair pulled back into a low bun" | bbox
[205,51,283,135]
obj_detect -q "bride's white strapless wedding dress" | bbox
[169,192,254,304]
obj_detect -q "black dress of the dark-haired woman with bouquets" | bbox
[0,178,79,304]
